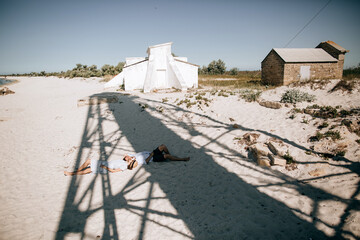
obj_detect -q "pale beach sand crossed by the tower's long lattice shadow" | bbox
[0,77,360,239]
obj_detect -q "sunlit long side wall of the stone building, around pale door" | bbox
[283,62,342,85]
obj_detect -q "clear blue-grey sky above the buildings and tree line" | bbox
[0,0,360,74]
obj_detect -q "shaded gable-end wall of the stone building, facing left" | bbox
[261,50,284,85]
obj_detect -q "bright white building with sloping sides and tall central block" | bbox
[105,42,199,92]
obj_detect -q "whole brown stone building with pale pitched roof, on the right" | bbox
[261,41,349,85]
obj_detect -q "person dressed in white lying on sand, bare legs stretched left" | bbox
[64,159,137,176]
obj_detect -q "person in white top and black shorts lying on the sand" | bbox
[124,144,190,168]
